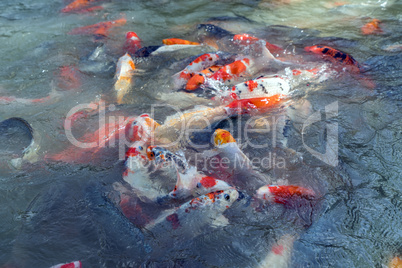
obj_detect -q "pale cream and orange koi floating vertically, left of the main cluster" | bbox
[114,53,135,104]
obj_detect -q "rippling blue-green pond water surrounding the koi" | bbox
[0,0,402,268]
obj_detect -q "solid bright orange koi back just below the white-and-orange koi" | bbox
[225,94,286,116]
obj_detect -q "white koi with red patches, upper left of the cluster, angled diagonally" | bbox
[173,53,219,87]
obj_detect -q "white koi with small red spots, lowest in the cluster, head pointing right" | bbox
[145,189,239,234]
